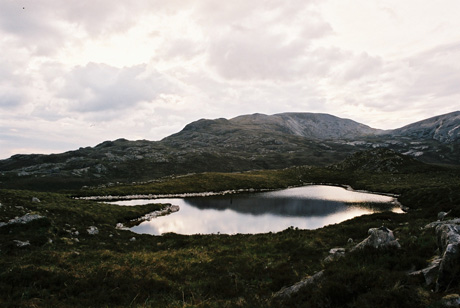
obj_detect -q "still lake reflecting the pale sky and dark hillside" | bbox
[109,185,399,235]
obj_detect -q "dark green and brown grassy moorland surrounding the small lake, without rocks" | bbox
[0,162,460,307]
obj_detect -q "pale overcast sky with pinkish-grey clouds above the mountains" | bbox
[0,0,460,159]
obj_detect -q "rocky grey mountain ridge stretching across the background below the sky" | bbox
[0,111,460,190]
